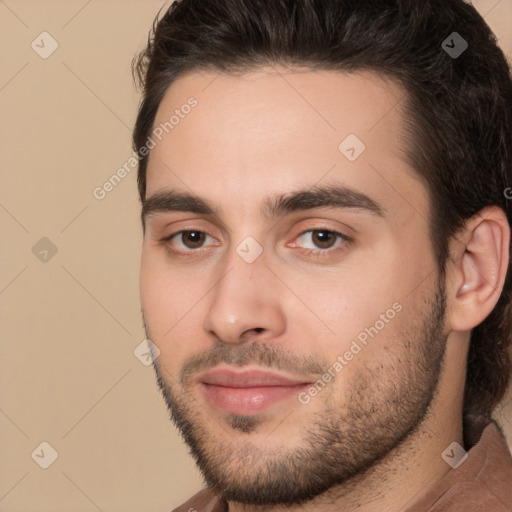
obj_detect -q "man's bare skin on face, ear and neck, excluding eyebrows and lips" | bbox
[140,66,510,512]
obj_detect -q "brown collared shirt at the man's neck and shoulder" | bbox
[173,415,512,512]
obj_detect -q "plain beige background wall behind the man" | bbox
[0,0,512,512]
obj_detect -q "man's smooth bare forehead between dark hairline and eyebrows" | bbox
[146,67,426,224]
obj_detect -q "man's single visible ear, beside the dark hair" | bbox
[446,206,510,331]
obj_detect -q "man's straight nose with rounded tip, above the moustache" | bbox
[203,244,286,344]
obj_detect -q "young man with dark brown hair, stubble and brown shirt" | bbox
[134,0,512,512]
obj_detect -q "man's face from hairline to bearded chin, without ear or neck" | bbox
[140,68,446,505]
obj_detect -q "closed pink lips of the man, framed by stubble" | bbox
[199,369,311,415]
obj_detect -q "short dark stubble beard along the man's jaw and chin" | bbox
[149,282,446,506]
